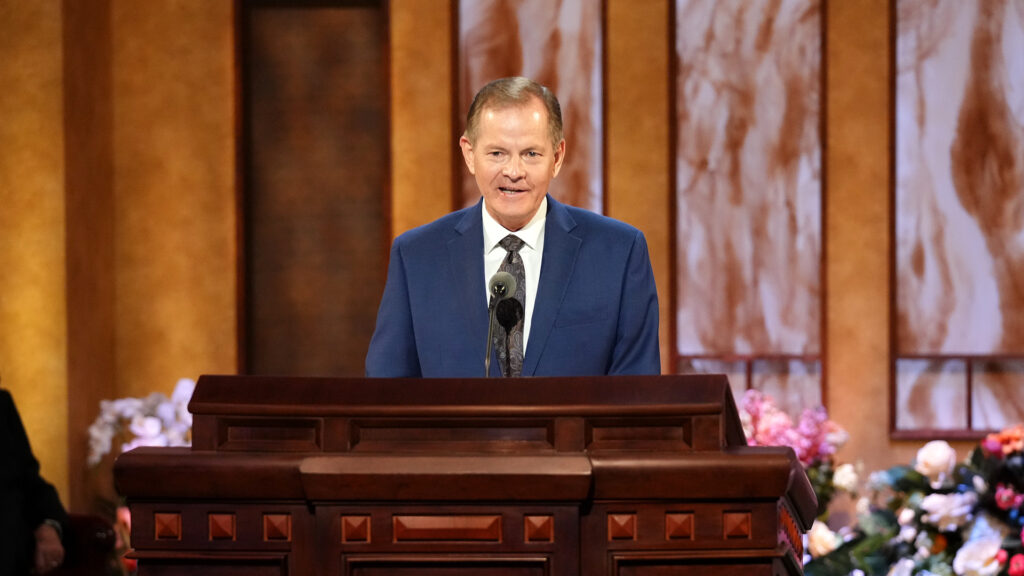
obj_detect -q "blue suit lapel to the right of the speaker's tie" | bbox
[524,196,583,376]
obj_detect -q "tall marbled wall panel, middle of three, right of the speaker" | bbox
[675,0,822,358]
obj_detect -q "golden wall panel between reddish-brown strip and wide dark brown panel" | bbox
[111,0,238,401]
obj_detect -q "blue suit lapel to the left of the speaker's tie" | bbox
[447,201,501,376]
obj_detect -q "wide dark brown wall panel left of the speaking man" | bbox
[242,2,390,376]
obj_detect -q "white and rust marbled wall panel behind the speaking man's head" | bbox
[458,0,604,212]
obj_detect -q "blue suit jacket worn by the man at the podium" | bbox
[367,196,660,377]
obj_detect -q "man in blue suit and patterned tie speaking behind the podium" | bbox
[367,78,660,377]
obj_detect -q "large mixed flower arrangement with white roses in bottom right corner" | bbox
[804,425,1024,576]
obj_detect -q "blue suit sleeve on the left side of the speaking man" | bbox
[367,240,421,378]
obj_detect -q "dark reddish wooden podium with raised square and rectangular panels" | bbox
[115,375,816,576]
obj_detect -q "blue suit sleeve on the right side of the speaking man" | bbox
[608,231,662,374]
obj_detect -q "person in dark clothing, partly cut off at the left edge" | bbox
[0,388,68,576]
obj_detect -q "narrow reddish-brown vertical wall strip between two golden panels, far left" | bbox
[63,0,117,506]
